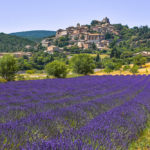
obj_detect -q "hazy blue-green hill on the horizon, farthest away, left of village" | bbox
[11,30,56,42]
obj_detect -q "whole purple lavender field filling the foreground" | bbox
[0,76,150,150]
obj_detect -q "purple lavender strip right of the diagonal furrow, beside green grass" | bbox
[27,77,150,150]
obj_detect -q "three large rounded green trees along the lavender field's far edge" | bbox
[0,54,95,81]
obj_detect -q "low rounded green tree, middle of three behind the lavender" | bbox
[45,60,68,78]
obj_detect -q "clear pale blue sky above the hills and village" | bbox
[0,0,150,33]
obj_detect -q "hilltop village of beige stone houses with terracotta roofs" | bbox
[42,17,119,53]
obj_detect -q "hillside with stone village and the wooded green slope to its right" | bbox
[46,17,150,54]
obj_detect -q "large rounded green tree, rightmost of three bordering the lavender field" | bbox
[71,54,95,75]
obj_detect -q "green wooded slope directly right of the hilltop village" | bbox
[110,24,150,52]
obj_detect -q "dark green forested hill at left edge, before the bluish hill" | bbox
[0,33,36,52]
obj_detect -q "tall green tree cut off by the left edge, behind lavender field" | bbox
[0,55,18,81]
